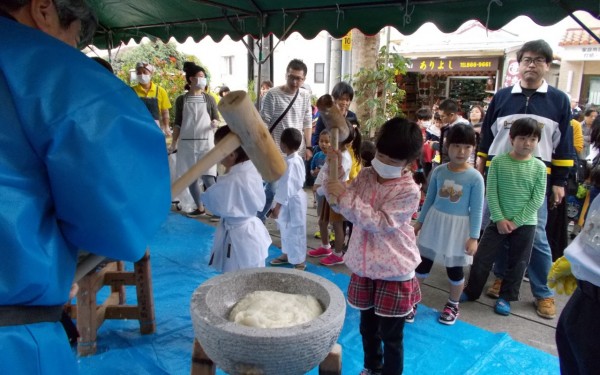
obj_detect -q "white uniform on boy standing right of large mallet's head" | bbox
[274,152,307,264]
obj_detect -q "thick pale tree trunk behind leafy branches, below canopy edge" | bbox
[352,29,380,134]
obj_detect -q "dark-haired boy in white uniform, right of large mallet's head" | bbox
[271,128,307,270]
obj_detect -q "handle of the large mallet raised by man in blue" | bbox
[171,133,242,198]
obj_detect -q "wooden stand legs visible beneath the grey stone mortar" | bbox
[191,339,342,375]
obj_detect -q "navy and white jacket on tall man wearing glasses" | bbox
[477,81,575,186]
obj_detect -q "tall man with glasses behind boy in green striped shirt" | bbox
[477,40,574,319]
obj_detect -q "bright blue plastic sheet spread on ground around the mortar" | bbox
[78,214,560,375]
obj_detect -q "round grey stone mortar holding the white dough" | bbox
[191,268,346,375]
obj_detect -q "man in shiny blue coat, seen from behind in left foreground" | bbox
[0,0,170,374]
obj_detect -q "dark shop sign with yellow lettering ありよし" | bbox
[408,57,498,73]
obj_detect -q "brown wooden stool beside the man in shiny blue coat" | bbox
[70,250,156,356]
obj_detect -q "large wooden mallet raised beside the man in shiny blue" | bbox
[171,91,287,197]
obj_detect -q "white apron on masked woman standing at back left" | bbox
[177,95,217,177]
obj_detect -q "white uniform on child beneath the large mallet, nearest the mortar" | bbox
[201,161,271,272]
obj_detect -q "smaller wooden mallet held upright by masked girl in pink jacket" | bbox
[317,94,350,205]
